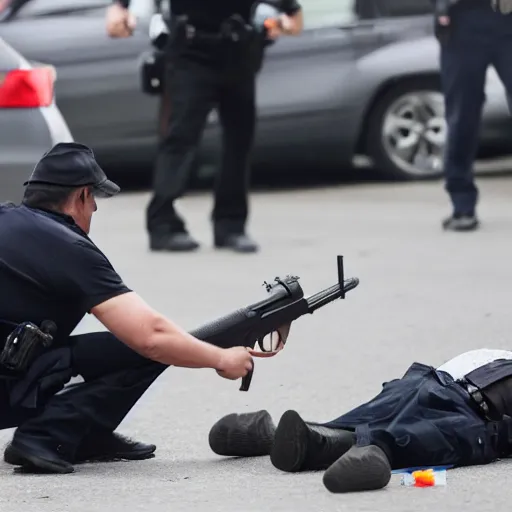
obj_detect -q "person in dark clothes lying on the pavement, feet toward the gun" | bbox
[209,349,512,493]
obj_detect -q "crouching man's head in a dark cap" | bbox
[22,142,120,233]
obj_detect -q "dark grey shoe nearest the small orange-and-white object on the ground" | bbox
[323,445,391,493]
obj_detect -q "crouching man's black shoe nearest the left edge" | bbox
[4,437,74,474]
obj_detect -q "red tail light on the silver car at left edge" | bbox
[0,66,55,108]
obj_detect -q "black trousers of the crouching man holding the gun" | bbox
[0,332,234,459]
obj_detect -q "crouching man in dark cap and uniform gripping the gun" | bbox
[0,143,264,473]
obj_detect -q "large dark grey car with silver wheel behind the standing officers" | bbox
[0,0,512,179]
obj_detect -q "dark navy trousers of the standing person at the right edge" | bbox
[441,1,512,214]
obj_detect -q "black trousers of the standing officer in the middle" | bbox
[147,42,256,236]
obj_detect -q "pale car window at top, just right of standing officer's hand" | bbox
[300,0,356,29]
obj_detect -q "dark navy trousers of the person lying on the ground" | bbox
[325,363,509,469]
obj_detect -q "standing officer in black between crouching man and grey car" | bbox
[107,0,302,252]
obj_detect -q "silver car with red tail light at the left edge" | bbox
[0,34,73,202]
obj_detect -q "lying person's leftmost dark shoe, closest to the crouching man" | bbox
[208,410,276,457]
